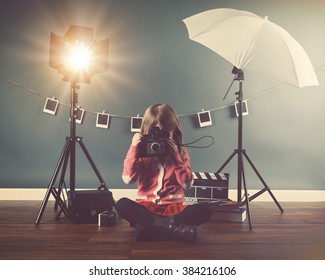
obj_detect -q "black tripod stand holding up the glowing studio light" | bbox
[35,82,107,225]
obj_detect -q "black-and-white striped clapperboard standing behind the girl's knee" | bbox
[184,172,229,204]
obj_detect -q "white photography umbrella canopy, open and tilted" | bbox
[183,9,318,88]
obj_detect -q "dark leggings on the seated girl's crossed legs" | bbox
[115,197,212,227]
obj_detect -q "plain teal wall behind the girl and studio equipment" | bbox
[0,0,325,190]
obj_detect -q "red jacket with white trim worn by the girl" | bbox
[122,145,193,204]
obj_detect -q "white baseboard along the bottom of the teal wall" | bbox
[0,188,325,202]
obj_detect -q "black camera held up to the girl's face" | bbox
[139,126,168,157]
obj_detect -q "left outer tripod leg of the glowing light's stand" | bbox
[35,139,71,225]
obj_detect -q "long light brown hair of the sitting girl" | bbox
[140,103,184,158]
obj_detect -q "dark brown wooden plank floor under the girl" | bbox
[0,201,325,260]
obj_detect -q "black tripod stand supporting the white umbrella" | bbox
[217,67,283,229]
